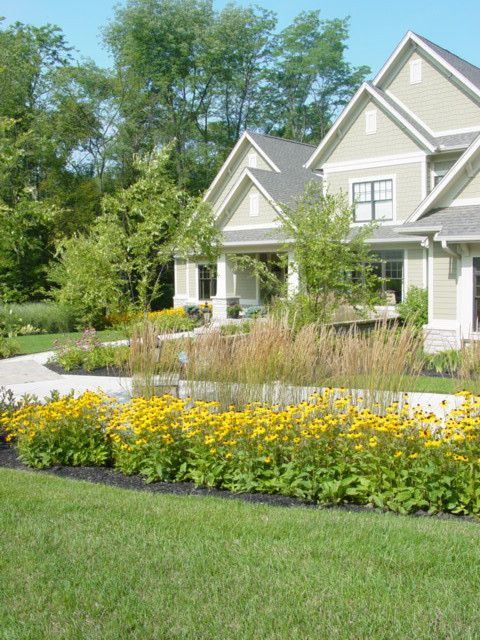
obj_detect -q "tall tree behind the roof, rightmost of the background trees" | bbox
[264,10,370,143]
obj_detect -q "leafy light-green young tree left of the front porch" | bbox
[51,148,218,324]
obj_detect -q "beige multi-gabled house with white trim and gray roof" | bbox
[174,32,480,352]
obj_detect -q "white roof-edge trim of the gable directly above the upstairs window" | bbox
[305,82,436,169]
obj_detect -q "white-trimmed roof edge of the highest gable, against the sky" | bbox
[373,31,480,97]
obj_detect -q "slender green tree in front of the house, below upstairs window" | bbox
[278,183,380,321]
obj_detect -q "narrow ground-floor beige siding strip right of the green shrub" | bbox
[433,245,457,320]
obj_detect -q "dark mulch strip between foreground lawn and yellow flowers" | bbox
[0,442,480,524]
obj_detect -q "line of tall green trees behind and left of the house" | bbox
[0,0,369,302]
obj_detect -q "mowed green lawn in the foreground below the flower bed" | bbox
[0,469,480,640]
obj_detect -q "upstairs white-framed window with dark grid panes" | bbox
[352,179,393,222]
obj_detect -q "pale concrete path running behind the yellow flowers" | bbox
[0,344,461,416]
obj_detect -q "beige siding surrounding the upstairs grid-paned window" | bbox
[326,162,422,221]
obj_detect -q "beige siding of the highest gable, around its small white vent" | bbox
[382,53,480,131]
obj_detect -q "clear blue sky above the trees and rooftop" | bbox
[0,0,480,72]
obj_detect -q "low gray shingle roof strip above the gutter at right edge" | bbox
[397,205,480,240]
